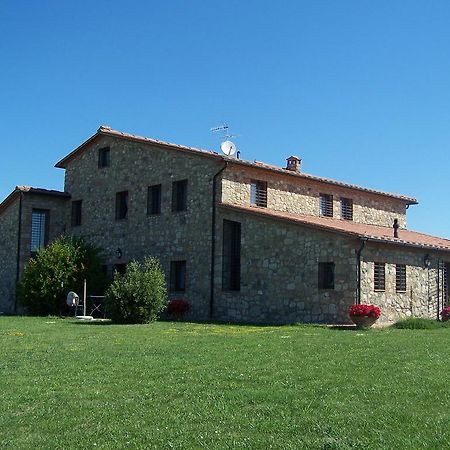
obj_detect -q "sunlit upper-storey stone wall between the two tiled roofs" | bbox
[222,165,406,228]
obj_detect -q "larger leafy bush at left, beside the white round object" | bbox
[17,236,108,315]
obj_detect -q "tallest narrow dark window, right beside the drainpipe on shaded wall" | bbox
[222,220,241,291]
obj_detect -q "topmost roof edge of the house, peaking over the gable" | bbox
[55,126,417,205]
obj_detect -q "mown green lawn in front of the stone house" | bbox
[0,317,450,450]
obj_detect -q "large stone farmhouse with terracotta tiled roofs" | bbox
[0,126,450,323]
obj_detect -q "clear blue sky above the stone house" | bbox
[0,0,450,238]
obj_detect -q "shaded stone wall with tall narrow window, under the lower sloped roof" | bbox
[214,208,357,323]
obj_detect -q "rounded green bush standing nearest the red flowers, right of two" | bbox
[106,258,167,323]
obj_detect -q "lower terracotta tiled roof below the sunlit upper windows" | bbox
[221,203,450,251]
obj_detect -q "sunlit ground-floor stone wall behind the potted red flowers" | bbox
[361,243,450,323]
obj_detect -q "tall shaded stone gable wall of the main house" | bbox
[65,137,225,319]
